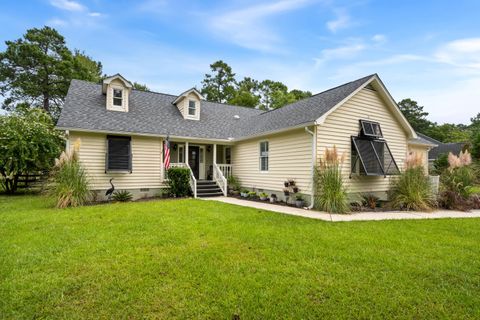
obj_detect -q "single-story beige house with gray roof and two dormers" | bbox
[57,74,434,202]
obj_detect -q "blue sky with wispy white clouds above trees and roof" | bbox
[0,0,480,123]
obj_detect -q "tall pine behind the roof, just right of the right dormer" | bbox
[201,60,237,103]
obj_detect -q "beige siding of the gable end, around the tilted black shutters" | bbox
[317,89,407,193]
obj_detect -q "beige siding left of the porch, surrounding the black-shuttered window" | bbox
[69,132,163,190]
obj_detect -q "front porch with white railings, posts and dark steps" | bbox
[165,141,233,198]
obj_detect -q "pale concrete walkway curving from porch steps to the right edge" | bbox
[205,197,480,222]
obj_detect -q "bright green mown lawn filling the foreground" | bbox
[0,196,480,319]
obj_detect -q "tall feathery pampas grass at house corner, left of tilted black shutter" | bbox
[314,146,350,213]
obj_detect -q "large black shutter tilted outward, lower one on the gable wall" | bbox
[351,137,400,176]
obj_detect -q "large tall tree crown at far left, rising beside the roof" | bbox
[0,26,101,118]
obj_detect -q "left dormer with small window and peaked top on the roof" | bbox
[102,73,133,112]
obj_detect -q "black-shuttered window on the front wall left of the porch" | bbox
[105,136,132,172]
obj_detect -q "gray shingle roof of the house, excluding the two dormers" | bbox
[57,75,373,139]
